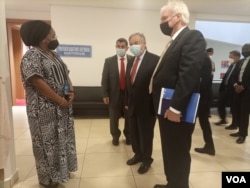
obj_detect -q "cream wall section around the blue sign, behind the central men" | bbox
[51,5,172,86]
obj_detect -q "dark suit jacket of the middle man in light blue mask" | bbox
[126,51,159,115]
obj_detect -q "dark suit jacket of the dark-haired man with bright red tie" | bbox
[101,55,133,105]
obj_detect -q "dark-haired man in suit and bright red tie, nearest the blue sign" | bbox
[101,38,133,146]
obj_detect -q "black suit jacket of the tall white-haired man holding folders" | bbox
[153,27,206,112]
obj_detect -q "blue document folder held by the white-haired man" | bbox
[158,88,200,123]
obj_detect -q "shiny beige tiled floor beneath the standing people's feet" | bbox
[10,106,250,188]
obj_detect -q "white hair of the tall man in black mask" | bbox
[161,0,189,24]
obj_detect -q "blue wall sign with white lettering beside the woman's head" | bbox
[56,44,92,57]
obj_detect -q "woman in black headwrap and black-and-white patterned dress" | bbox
[20,20,77,188]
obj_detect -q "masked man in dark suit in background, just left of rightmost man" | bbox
[215,50,240,130]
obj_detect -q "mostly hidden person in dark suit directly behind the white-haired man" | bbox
[194,53,215,155]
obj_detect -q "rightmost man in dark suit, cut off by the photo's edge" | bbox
[230,43,250,144]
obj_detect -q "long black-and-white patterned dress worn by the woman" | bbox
[20,47,77,184]
